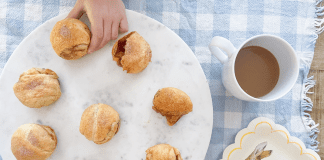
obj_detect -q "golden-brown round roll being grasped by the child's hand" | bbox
[50,18,91,60]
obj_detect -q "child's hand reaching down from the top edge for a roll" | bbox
[67,0,128,53]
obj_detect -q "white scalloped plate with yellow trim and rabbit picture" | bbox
[222,117,321,160]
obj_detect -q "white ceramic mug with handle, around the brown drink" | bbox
[209,35,299,101]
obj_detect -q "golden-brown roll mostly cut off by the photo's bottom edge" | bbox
[146,144,182,160]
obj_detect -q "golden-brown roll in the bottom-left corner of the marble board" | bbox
[11,124,57,160]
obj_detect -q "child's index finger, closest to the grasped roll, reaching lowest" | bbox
[88,18,104,54]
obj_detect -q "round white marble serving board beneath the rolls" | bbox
[0,10,213,160]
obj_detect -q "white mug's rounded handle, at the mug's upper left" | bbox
[209,36,236,64]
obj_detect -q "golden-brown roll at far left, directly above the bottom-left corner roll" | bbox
[13,68,61,108]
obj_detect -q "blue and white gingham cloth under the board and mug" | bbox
[0,0,316,160]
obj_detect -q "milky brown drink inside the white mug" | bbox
[235,46,280,98]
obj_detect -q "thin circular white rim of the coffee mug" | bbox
[232,34,299,102]
